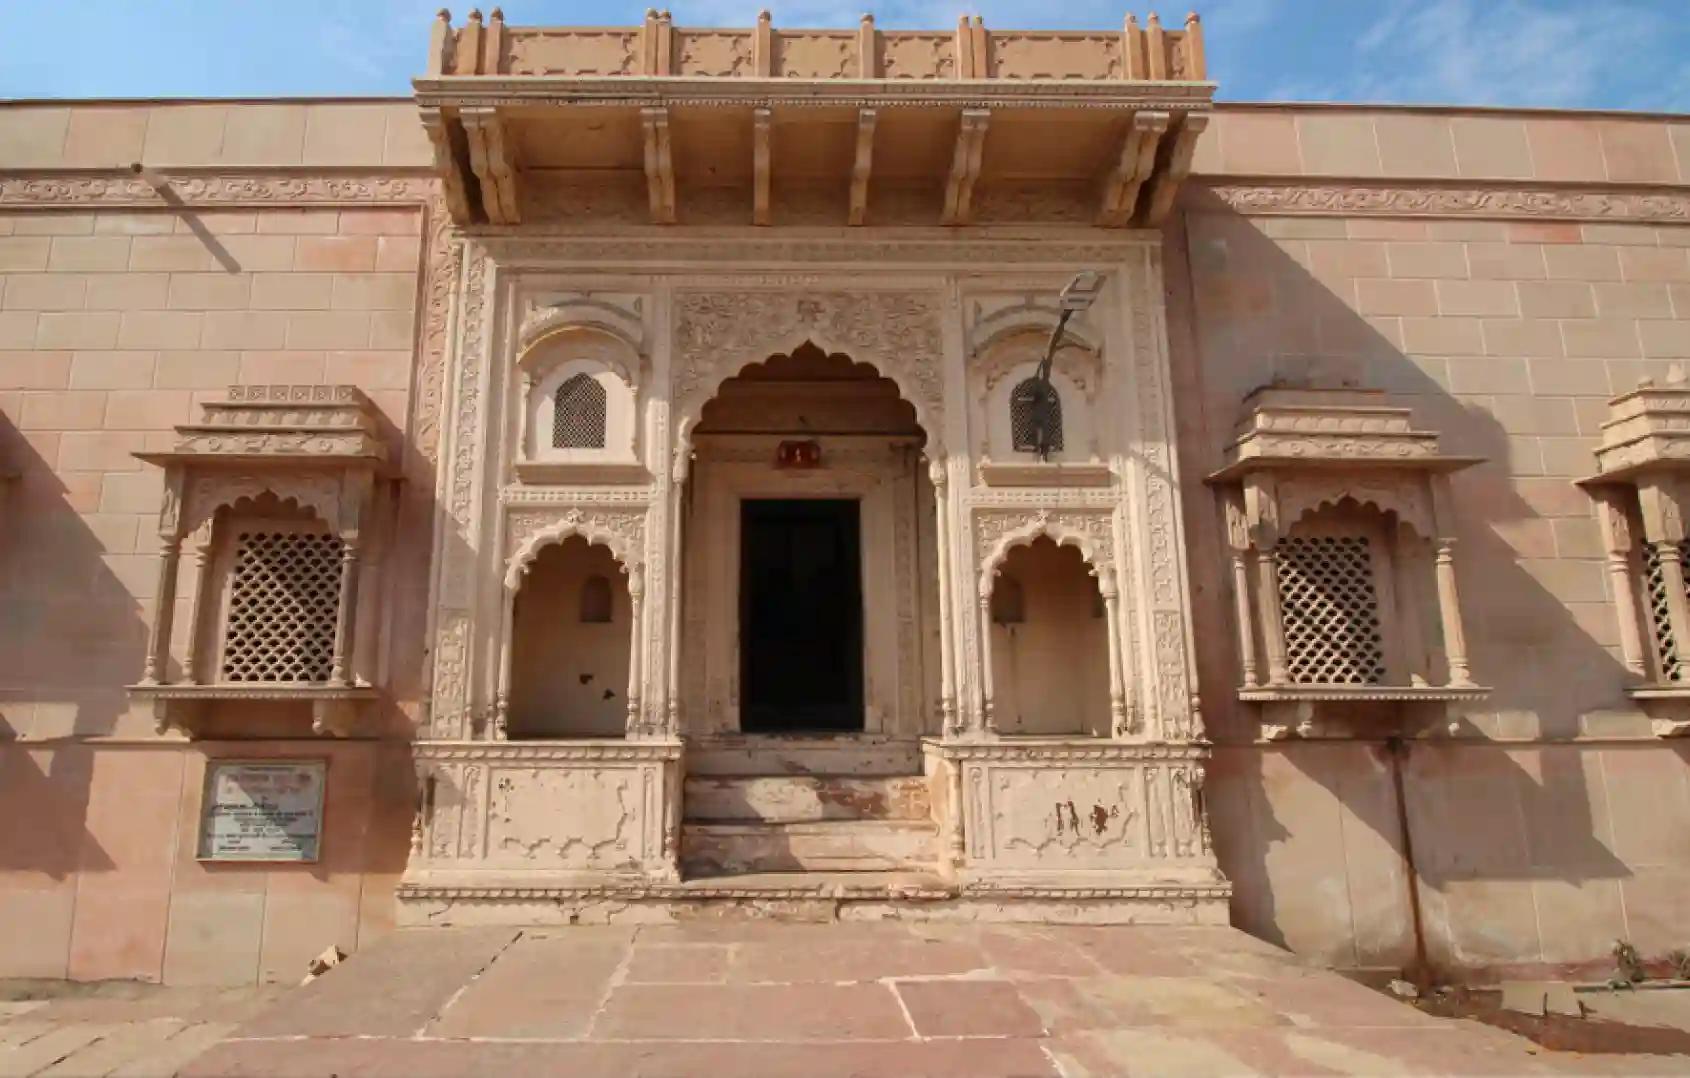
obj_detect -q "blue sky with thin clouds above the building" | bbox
[0,0,1690,112]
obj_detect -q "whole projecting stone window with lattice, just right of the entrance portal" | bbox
[1208,389,1489,733]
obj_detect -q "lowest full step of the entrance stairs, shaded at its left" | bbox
[681,819,936,877]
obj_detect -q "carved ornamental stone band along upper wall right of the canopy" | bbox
[1190,179,1690,223]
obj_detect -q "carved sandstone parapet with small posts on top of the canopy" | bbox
[428,7,1208,81]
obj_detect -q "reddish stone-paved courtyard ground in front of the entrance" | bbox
[0,921,1690,1078]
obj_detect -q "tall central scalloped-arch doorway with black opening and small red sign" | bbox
[681,341,938,738]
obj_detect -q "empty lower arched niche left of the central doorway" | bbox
[505,536,632,740]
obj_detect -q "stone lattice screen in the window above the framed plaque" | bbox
[223,531,341,681]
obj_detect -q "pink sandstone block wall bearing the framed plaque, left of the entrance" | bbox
[0,103,431,983]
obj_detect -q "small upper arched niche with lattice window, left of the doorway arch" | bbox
[517,323,641,466]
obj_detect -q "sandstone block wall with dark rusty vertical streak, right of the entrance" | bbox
[1168,108,1690,970]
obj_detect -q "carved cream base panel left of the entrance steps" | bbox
[401,740,681,897]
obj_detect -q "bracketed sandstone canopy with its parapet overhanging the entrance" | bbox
[414,8,1215,228]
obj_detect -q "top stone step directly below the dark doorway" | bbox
[686,733,921,776]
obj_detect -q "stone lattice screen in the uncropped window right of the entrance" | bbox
[1278,536,1384,684]
